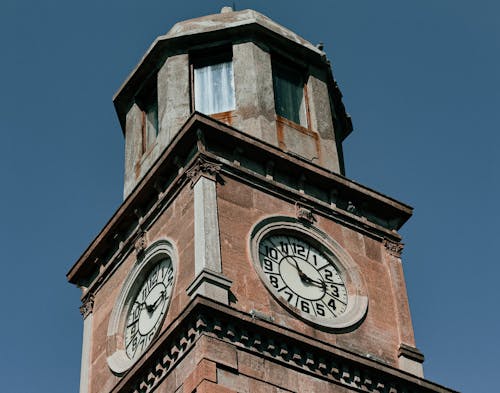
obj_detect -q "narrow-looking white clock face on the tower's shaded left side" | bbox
[124,258,174,360]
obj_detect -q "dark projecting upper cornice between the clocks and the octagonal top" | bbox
[67,113,412,288]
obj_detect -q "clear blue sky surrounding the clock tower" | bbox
[0,0,500,393]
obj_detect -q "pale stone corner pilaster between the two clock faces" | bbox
[187,158,231,304]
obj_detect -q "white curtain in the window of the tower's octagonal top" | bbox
[194,61,235,115]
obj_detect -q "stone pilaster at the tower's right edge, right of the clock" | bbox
[384,240,424,378]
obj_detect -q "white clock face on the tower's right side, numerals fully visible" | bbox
[258,233,349,318]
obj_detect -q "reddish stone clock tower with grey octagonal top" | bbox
[67,7,458,393]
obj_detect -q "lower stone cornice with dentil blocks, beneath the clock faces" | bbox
[112,297,453,393]
